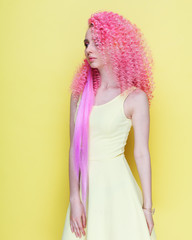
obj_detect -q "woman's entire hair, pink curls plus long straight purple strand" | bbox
[70,11,154,215]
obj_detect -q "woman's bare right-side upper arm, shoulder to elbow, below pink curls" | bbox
[132,90,150,157]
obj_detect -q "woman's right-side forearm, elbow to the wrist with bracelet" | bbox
[135,152,152,208]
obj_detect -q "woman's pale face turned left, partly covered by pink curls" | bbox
[84,28,104,69]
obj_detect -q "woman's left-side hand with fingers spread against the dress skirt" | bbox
[70,199,86,238]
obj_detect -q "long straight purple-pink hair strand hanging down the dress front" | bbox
[73,66,94,216]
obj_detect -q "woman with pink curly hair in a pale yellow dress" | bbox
[62,11,156,240]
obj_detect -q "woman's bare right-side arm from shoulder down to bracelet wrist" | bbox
[132,90,152,208]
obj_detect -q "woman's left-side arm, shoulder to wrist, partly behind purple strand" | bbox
[69,95,80,202]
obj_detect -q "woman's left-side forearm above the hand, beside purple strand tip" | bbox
[69,148,80,202]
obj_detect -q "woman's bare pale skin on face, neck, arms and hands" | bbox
[69,28,154,238]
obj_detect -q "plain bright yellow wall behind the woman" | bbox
[0,0,192,240]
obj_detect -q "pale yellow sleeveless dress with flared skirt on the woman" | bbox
[62,87,156,240]
